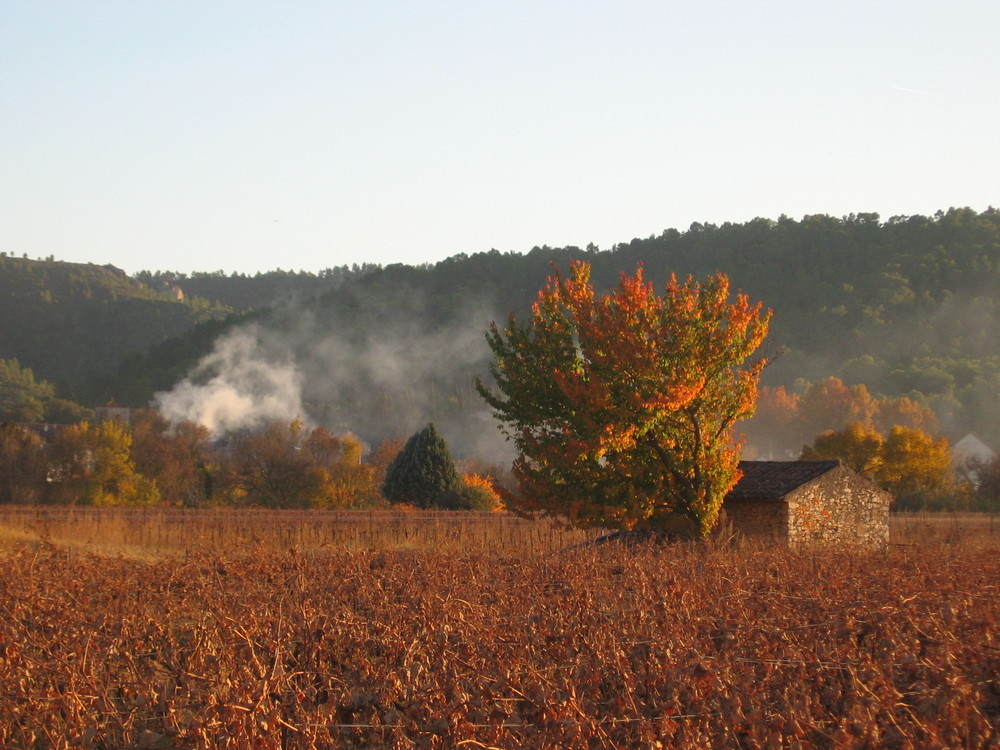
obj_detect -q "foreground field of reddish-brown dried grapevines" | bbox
[0,516,1000,748]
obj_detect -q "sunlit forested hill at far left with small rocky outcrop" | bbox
[0,255,229,399]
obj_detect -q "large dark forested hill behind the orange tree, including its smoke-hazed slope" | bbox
[99,209,1000,452]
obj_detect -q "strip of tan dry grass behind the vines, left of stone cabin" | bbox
[0,506,598,561]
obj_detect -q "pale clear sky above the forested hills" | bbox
[0,0,1000,273]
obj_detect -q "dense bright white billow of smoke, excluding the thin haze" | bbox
[153,326,304,435]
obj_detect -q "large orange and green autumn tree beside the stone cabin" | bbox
[477,262,770,534]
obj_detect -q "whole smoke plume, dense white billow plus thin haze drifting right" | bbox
[154,297,510,463]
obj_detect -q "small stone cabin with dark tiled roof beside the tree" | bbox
[722,460,892,547]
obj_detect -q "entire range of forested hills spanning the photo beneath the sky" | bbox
[7,208,1000,453]
